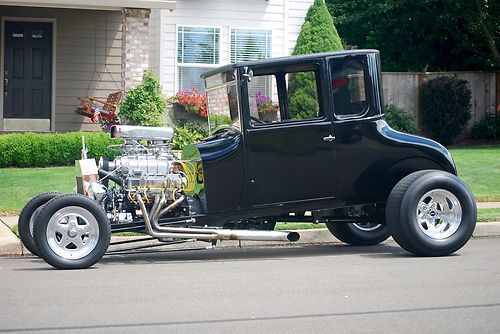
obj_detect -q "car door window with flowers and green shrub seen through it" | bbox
[247,70,323,126]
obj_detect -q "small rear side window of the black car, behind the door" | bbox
[330,58,370,118]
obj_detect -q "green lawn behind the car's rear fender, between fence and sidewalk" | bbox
[450,145,500,202]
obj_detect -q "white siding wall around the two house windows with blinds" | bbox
[152,0,313,96]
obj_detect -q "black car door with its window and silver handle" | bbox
[241,62,335,207]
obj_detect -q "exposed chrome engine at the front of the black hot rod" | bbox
[90,125,190,222]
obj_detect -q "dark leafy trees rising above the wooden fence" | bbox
[326,0,500,71]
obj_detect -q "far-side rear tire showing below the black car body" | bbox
[326,222,391,246]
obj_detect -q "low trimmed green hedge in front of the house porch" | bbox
[0,132,121,167]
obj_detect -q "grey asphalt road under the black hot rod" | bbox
[0,238,500,334]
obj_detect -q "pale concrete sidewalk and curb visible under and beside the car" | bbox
[0,202,500,256]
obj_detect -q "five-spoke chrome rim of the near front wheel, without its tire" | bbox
[46,206,99,260]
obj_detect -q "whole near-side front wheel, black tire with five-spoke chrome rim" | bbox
[33,194,111,269]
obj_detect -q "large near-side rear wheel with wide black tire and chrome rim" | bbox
[386,171,477,256]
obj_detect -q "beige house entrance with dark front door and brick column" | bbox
[0,0,175,131]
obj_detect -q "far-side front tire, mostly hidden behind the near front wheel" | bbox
[17,192,61,256]
